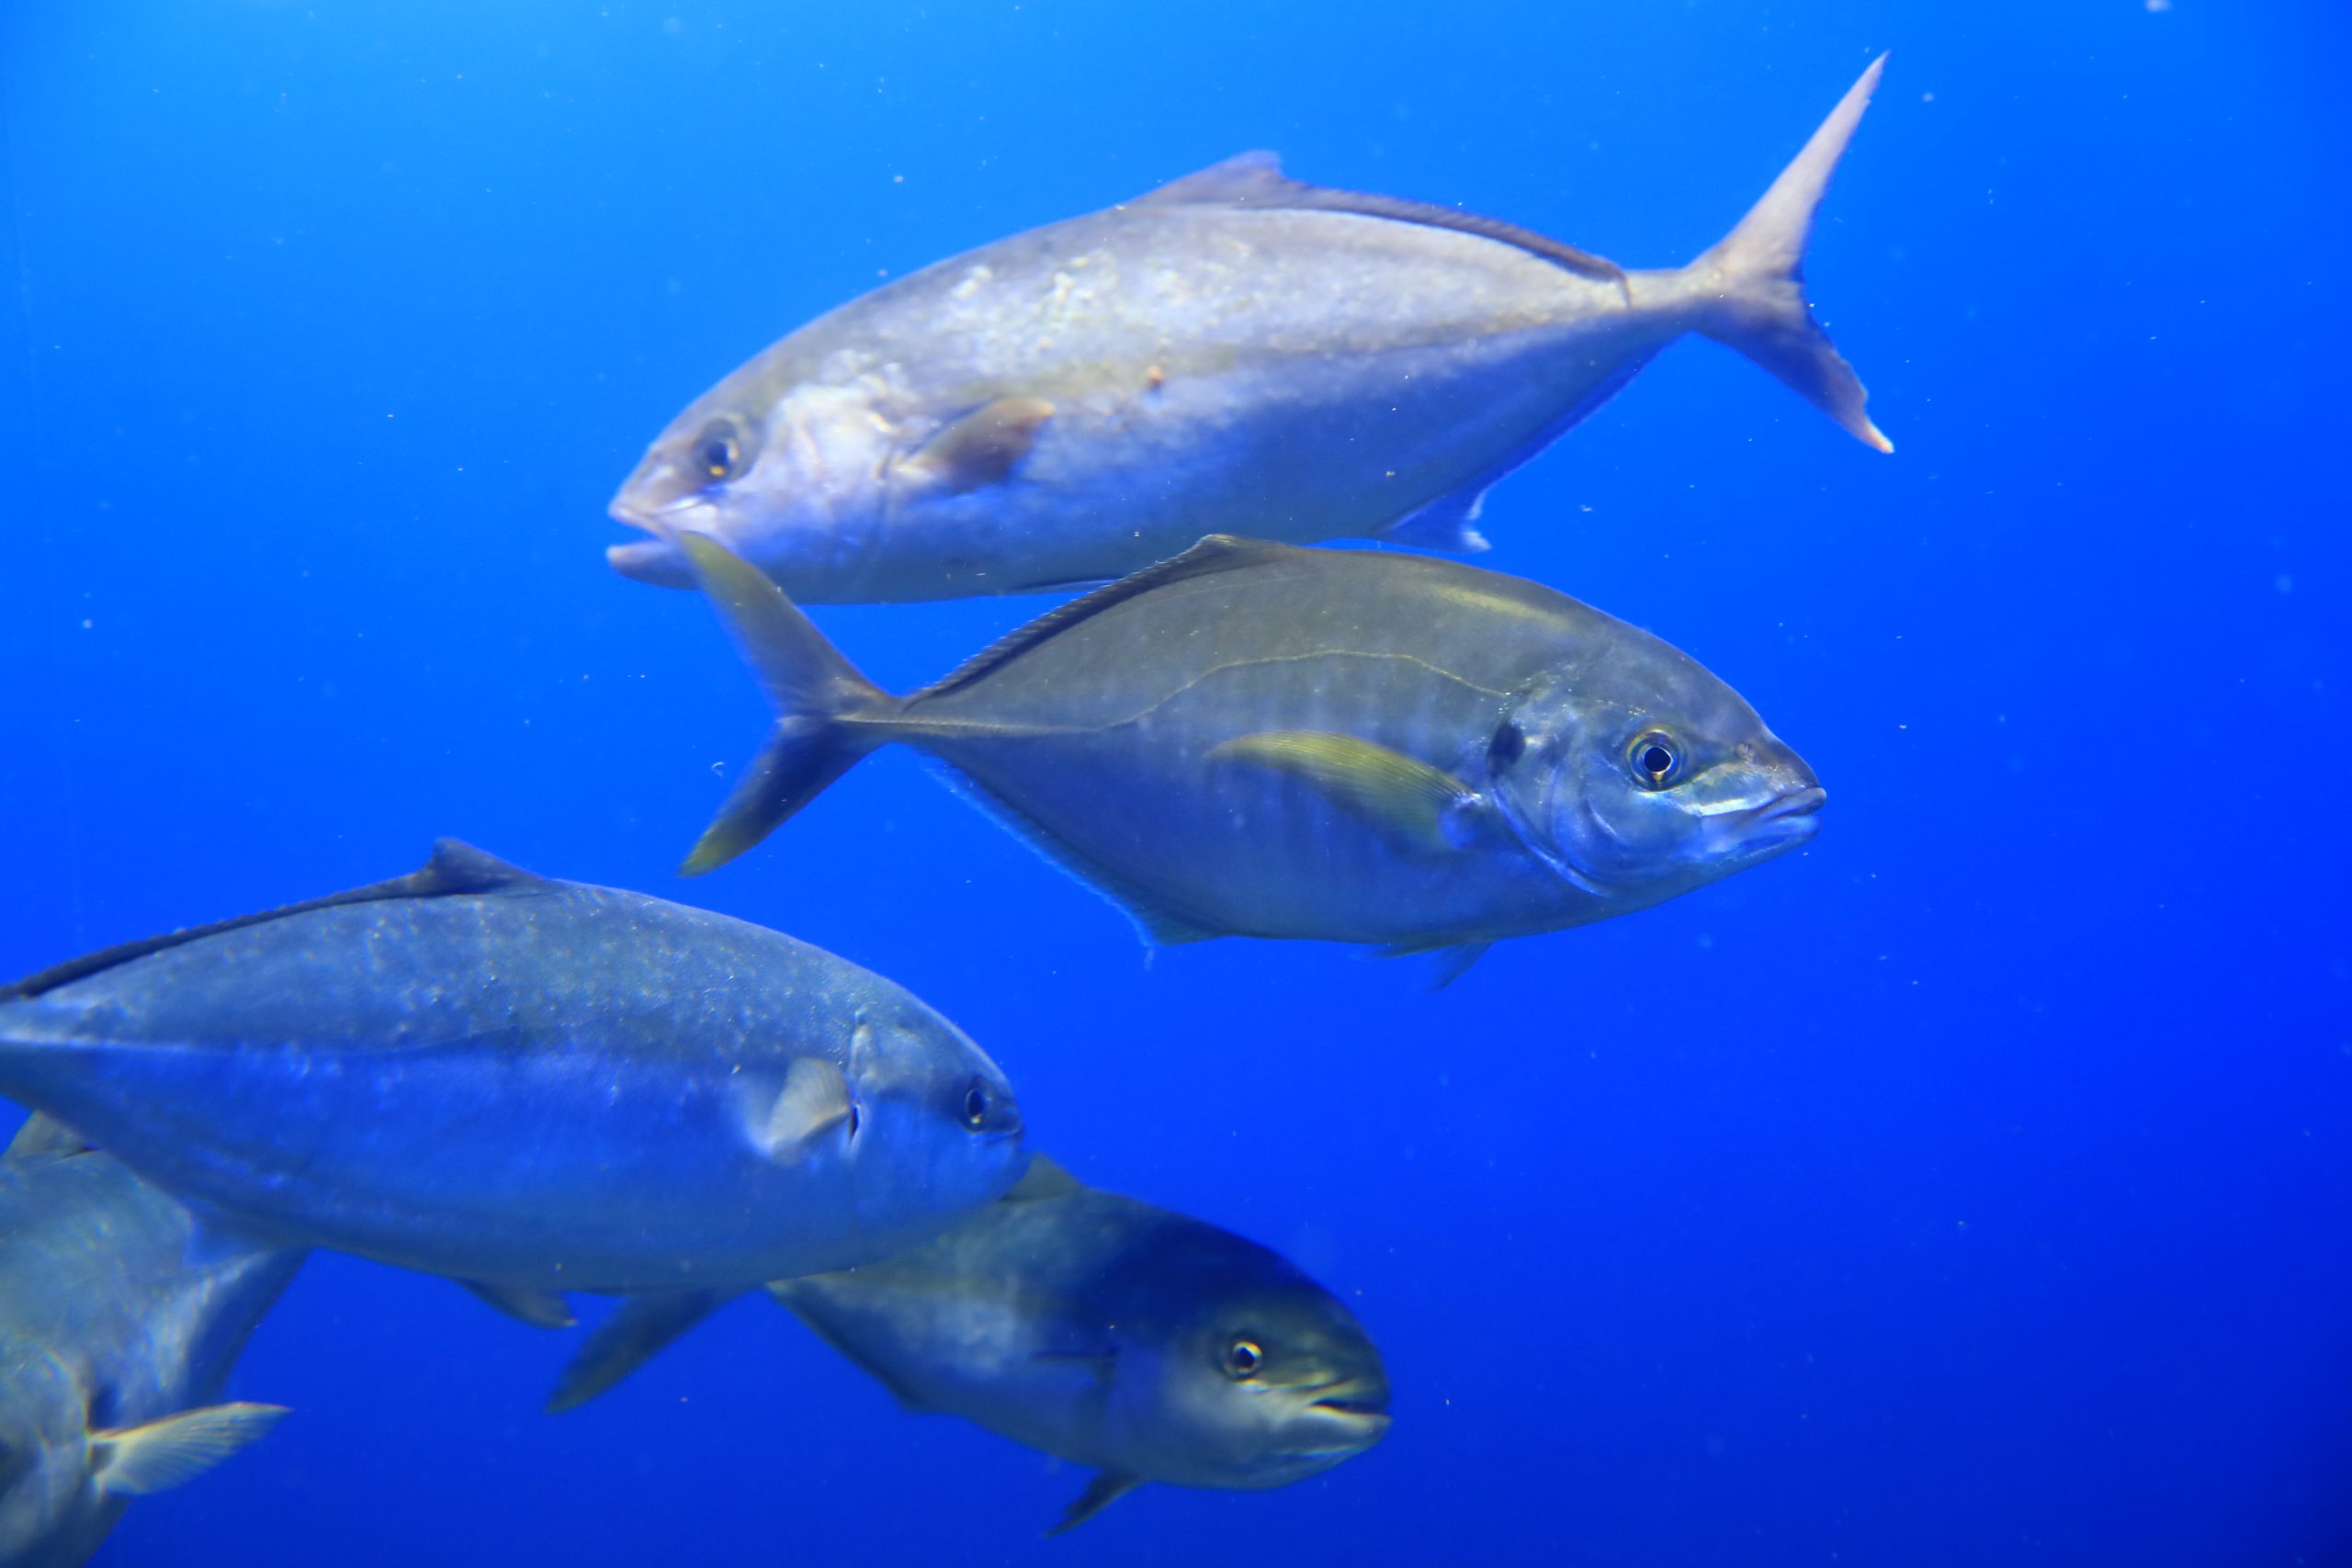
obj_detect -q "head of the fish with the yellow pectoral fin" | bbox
[1487,626,1827,909]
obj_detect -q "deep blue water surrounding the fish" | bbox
[0,0,2352,1568]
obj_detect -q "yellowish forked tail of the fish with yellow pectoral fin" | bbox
[677,534,899,877]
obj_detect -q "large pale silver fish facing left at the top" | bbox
[606,56,1894,604]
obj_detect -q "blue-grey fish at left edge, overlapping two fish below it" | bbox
[0,840,1028,1321]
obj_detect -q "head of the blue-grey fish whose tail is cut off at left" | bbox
[847,1001,1028,1236]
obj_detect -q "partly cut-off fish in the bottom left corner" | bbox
[0,1117,306,1568]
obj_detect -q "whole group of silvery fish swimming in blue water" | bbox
[0,59,1891,1568]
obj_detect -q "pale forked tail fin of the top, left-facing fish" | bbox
[1691,54,1895,451]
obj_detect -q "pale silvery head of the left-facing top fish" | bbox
[605,360,891,588]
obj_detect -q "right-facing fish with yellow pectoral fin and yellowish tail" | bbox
[682,534,1827,978]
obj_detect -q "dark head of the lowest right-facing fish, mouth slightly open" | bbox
[1117,1256,1387,1488]
